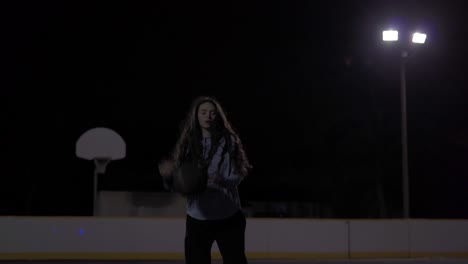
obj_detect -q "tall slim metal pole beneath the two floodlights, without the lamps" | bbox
[400,51,410,218]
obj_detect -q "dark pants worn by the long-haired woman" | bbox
[185,211,247,264]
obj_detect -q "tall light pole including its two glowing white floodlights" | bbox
[382,30,426,218]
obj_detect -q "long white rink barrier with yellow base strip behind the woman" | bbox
[0,216,468,260]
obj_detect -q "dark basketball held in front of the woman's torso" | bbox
[173,162,208,195]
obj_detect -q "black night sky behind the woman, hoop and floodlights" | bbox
[0,0,468,218]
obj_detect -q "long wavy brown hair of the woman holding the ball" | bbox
[172,96,252,177]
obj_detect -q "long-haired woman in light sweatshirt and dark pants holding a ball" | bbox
[158,97,252,264]
